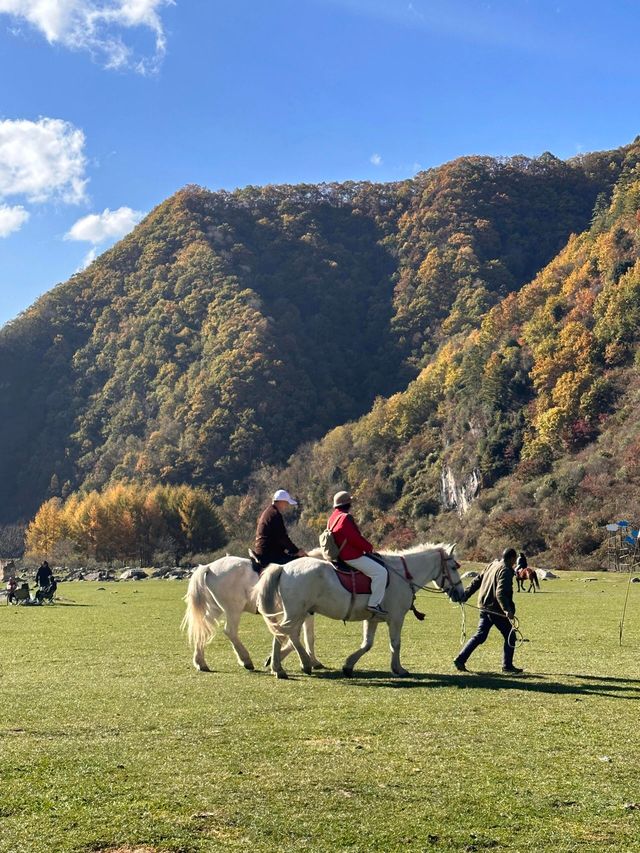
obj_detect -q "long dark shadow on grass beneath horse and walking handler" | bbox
[314,670,640,699]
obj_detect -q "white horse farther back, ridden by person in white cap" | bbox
[182,555,323,672]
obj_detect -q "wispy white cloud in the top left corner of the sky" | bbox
[0,0,173,74]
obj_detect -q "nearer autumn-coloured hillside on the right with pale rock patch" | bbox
[254,138,640,567]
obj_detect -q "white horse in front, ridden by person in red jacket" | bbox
[257,544,464,678]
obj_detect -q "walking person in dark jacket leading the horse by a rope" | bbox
[453,548,522,675]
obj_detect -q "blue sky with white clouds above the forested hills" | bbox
[0,0,640,323]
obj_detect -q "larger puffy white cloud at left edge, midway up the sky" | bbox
[0,118,87,204]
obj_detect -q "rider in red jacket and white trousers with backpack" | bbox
[327,492,388,616]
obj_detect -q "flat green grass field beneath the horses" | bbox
[0,574,640,853]
